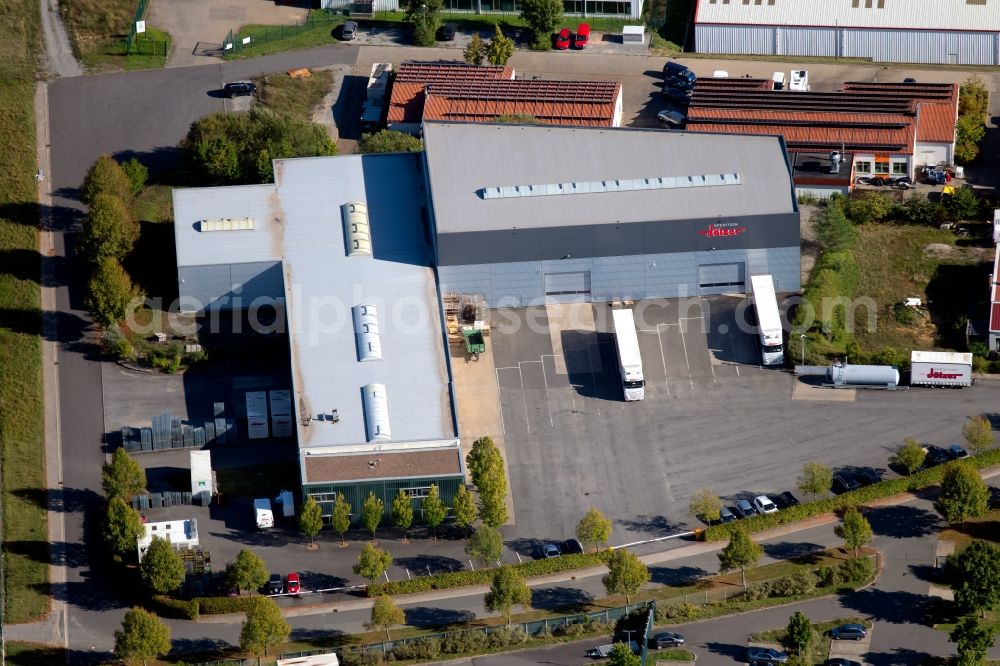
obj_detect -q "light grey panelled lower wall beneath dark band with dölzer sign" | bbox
[438,247,801,307]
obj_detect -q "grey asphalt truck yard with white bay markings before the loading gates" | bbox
[491,296,1000,543]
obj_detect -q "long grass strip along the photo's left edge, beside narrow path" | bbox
[0,0,49,622]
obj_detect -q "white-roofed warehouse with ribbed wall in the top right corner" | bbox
[695,0,1000,65]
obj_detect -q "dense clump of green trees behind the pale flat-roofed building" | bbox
[181,105,337,185]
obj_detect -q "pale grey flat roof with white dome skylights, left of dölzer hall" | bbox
[174,154,456,448]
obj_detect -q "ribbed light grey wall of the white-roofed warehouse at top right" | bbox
[695,25,1000,65]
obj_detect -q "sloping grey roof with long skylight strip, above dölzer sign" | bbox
[424,122,796,233]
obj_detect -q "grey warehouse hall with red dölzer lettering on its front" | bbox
[424,123,800,307]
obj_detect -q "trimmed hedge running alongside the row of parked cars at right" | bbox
[705,448,1000,541]
